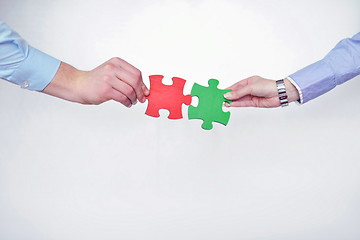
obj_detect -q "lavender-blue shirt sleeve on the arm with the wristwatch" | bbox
[288,33,360,103]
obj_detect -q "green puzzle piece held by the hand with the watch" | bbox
[188,79,231,130]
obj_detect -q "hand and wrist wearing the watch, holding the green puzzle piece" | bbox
[225,76,300,108]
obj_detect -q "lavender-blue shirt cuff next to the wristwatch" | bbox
[289,60,336,103]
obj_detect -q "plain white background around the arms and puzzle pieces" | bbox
[0,0,360,240]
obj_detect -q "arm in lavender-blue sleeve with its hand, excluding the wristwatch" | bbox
[225,33,360,107]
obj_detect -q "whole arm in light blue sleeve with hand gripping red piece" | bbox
[0,21,149,107]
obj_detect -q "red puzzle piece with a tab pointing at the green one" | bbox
[145,75,191,119]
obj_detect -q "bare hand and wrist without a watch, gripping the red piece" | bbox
[42,58,149,107]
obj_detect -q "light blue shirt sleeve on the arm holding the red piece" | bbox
[0,21,60,91]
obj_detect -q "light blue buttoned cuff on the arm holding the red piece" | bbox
[9,46,60,91]
